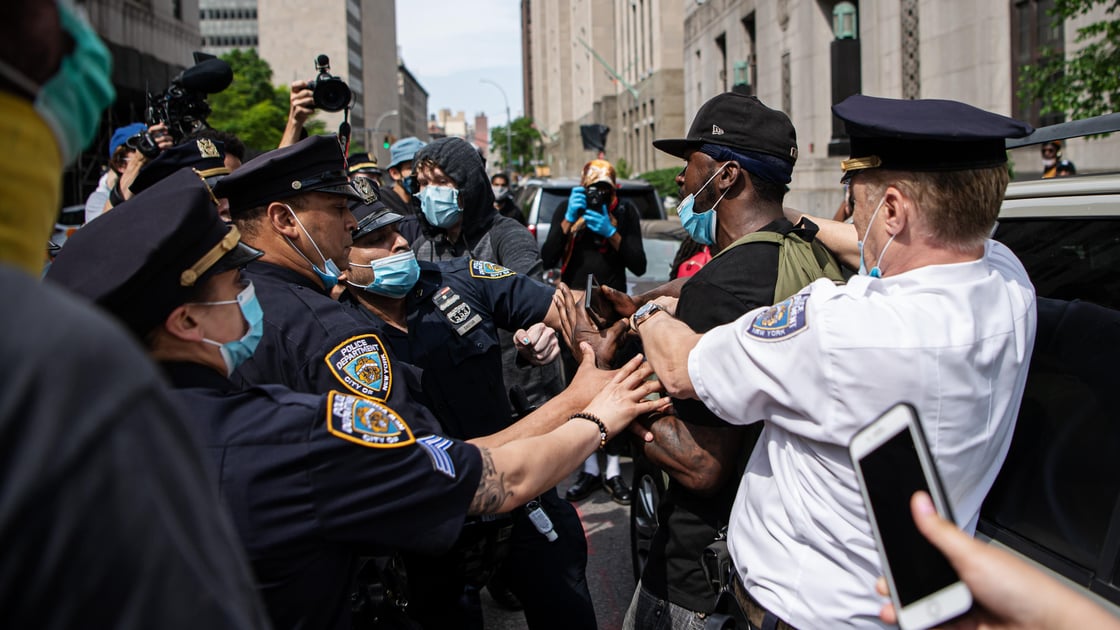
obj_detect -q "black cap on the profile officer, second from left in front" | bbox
[214,136,376,219]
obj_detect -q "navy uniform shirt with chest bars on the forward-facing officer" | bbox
[340,257,556,439]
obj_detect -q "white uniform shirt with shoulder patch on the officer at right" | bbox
[689,241,1036,628]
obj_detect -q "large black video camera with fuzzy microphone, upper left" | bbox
[134,53,233,159]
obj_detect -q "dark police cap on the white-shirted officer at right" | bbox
[832,94,1034,176]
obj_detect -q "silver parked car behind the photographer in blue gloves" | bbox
[514,177,665,245]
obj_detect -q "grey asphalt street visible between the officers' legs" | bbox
[483,457,634,630]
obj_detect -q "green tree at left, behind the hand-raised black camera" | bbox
[207,48,326,151]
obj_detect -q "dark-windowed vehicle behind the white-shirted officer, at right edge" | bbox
[631,114,1120,614]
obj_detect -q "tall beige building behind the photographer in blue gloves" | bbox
[522,0,684,175]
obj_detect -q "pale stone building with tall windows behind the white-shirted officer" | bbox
[684,0,1120,216]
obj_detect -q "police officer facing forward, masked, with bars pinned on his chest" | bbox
[343,205,596,629]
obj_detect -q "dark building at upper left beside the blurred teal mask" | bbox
[75,0,200,204]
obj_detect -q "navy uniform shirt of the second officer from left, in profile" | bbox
[233,261,439,433]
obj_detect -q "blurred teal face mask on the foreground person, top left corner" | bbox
[0,0,116,166]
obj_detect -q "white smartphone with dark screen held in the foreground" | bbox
[849,402,972,630]
